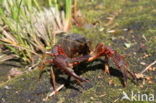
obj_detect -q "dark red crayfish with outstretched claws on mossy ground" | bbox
[39,34,136,96]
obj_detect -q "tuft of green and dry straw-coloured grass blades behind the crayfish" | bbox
[0,0,72,63]
